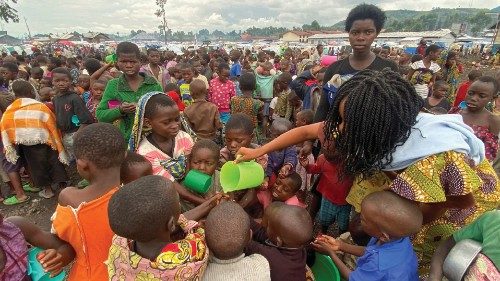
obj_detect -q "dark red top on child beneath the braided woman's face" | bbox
[306,154,353,205]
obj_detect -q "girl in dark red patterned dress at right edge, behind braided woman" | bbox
[453,76,500,161]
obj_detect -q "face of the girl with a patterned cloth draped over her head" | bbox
[145,106,181,139]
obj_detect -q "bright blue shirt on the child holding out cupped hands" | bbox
[349,237,419,281]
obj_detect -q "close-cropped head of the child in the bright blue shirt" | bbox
[361,191,423,238]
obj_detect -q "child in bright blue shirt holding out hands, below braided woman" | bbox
[313,191,422,281]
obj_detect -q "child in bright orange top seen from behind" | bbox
[52,123,125,281]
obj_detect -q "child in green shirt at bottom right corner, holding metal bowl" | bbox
[427,209,500,281]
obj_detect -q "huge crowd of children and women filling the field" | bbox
[0,4,500,281]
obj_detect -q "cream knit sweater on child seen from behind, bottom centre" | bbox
[202,254,271,281]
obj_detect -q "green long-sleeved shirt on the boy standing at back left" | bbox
[96,74,163,140]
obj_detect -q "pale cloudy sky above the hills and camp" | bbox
[2,0,496,36]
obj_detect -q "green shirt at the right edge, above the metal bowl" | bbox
[453,210,500,269]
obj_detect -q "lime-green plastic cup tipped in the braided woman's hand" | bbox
[220,161,264,192]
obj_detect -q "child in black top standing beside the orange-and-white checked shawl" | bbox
[52,67,94,161]
